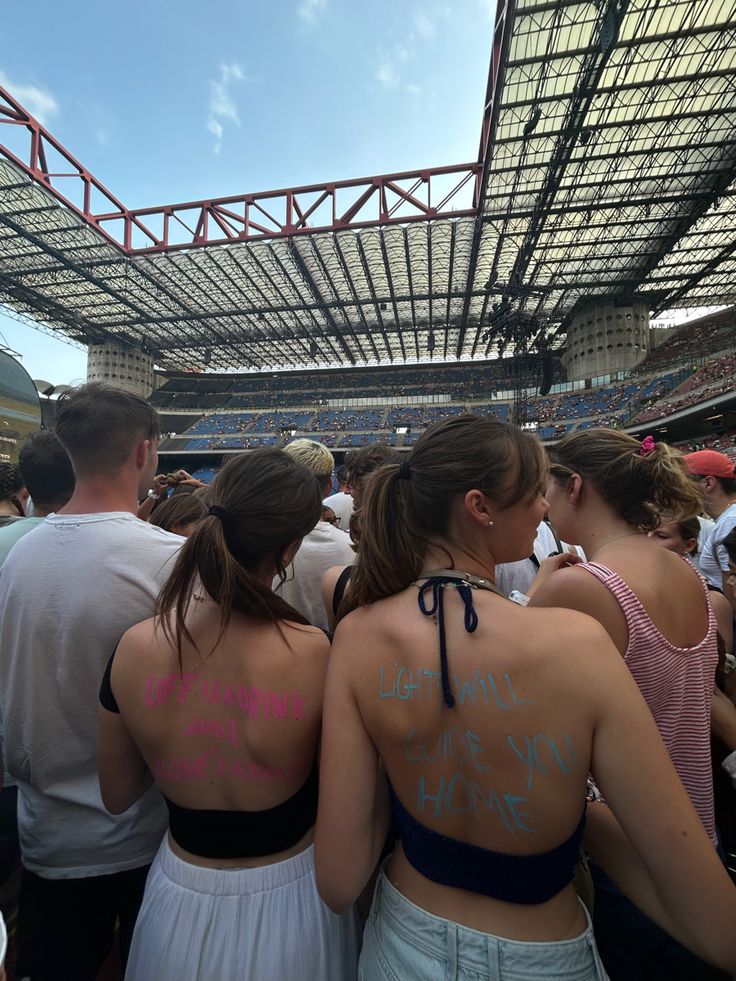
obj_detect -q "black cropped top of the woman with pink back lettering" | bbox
[100,653,319,859]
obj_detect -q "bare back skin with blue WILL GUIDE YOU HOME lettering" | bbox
[346,586,600,940]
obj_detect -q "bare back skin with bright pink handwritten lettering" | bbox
[112,599,329,868]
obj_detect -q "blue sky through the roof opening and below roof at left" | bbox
[0,0,495,383]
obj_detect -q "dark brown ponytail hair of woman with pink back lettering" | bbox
[154,449,322,665]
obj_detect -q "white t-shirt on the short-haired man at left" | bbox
[0,511,183,879]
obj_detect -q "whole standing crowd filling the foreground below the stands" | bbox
[0,384,736,981]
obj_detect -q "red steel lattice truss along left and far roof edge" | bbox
[0,87,482,255]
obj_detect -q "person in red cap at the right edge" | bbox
[685,450,736,609]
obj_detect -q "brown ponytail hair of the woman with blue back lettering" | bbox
[338,414,547,617]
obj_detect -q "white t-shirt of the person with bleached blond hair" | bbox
[273,521,355,628]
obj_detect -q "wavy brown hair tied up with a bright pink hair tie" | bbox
[549,429,703,531]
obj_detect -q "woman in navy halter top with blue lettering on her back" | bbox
[315,415,736,981]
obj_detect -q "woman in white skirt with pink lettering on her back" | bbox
[100,449,358,981]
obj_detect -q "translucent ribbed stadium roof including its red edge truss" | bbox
[0,0,736,370]
